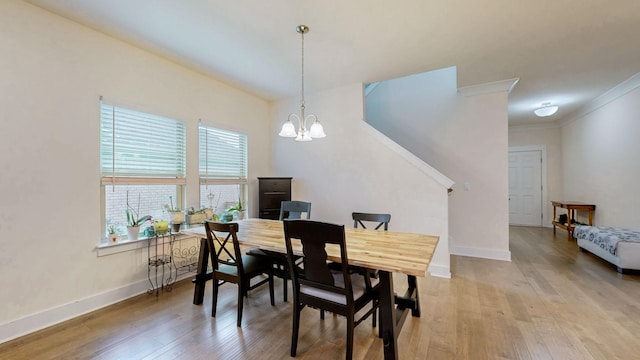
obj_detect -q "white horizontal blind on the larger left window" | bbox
[100,102,186,184]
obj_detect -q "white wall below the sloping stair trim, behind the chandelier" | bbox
[273,84,450,277]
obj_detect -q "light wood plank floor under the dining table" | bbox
[0,227,640,359]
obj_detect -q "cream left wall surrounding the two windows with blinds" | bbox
[0,0,272,341]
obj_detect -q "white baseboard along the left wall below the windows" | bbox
[0,273,193,344]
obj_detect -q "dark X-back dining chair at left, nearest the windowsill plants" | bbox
[204,220,275,327]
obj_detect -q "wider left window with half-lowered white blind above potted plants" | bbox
[100,102,186,242]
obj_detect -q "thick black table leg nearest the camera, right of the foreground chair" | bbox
[379,271,398,360]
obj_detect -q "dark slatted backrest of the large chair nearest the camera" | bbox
[284,220,353,303]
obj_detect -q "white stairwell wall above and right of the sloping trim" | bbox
[366,67,511,260]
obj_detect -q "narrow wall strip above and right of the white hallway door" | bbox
[509,126,564,227]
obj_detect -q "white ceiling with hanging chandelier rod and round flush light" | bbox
[25,0,640,126]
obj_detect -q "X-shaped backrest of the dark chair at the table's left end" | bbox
[204,220,244,275]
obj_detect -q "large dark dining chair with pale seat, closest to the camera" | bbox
[284,220,379,359]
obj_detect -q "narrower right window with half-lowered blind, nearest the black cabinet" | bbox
[199,125,247,214]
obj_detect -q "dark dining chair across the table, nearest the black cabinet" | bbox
[248,201,312,300]
